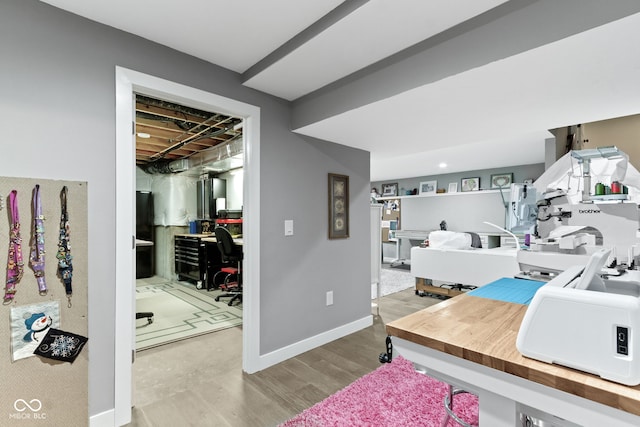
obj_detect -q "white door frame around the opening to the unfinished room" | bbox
[114,66,261,425]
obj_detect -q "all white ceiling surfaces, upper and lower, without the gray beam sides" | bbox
[43,0,640,181]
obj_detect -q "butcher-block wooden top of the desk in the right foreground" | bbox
[387,295,640,415]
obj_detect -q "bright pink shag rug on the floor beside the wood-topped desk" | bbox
[280,356,478,427]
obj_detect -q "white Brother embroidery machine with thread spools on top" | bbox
[518,147,640,279]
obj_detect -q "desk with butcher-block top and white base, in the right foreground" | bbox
[387,294,640,427]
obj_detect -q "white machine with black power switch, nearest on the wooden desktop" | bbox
[516,249,640,386]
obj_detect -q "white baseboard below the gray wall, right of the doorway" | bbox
[258,315,373,372]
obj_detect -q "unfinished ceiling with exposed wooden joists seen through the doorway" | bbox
[136,95,242,173]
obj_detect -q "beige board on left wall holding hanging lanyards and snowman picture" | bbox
[0,177,91,427]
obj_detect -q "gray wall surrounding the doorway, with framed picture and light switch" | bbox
[0,0,370,415]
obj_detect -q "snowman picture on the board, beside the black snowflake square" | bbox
[11,301,60,362]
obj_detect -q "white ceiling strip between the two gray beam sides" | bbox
[245,0,506,100]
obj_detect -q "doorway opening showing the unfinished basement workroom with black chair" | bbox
[135,94,244,352]
